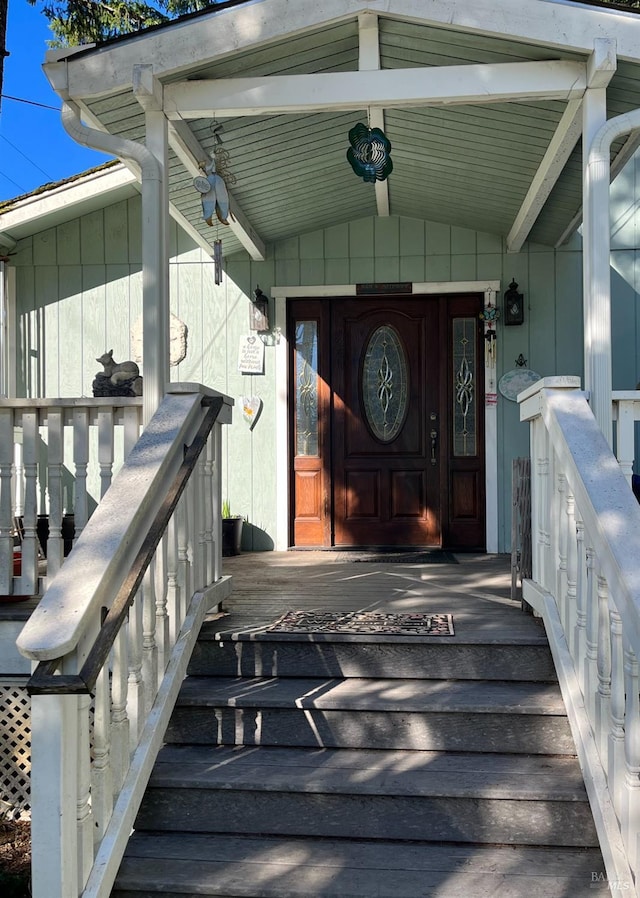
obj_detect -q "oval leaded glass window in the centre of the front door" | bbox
[361,324,409,443]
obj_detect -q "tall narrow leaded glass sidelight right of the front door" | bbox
[453,318,477,457]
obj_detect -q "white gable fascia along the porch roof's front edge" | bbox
[45,0,640,100]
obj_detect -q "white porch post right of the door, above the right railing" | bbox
[582,88,613,446]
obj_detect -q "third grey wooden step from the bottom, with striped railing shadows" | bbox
[166,677,575,755]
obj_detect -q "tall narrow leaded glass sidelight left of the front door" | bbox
[296,321,318,455]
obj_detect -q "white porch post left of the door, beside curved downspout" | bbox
[133,65,169,424]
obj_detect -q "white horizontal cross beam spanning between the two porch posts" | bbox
[164,60,587,119]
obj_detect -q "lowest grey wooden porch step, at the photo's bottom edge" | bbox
[117,833,610,898]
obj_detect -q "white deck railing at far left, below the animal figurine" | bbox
[0,399,142,595]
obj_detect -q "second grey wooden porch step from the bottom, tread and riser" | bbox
[136,746,598,847]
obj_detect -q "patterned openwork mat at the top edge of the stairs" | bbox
[266,611,454,636]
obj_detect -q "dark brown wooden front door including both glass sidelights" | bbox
[289,296,485,549]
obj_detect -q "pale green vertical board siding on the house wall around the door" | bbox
[12,190,640,551]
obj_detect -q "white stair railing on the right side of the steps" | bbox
[518,378,640,895]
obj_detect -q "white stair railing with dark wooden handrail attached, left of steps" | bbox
[18,384,233,898]
